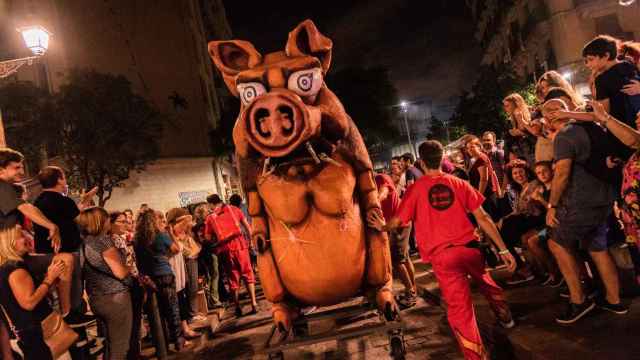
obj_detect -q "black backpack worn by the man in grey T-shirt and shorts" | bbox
[573,122,622,185]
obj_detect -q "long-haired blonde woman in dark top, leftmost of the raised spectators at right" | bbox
[502,93,539,164]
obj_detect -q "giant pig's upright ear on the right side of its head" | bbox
[285,19,333,74]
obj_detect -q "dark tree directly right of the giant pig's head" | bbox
[326,67,398,152]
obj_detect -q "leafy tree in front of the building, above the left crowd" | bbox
[55,69,165,206]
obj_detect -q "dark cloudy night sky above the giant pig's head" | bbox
[224,0,480,103]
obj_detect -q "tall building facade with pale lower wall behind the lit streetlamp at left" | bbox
[0,0,239,210]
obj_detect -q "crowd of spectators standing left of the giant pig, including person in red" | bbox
[0,148,258,359]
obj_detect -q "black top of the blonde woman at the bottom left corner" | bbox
[0,261,52,330]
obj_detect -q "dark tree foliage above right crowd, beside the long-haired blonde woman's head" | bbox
[451,65,535,137]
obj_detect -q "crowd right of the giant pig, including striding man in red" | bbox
[376,35,640,359]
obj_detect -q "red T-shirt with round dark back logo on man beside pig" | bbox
[396,174,484,261]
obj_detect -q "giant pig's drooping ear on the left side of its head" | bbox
[209,40,262,96]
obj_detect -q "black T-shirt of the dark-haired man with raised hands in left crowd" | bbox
[34,191,82,254]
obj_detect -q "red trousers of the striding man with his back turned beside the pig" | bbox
[431,246,511,360]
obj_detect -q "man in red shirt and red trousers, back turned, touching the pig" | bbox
[367,140,516,359]
